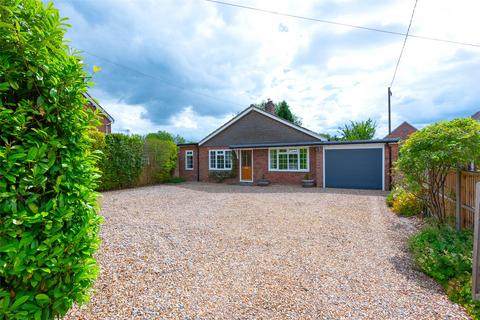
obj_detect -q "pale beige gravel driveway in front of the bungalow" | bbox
[67,183,467,319]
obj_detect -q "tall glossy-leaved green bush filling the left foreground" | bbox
[0,0,101,319]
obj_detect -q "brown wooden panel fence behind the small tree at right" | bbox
[445,171,480,229]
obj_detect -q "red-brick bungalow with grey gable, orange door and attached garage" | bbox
[178,103,399,190]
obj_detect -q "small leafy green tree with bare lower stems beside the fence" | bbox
[396,118,480,222]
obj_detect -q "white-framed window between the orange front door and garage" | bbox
[268,148,309,171]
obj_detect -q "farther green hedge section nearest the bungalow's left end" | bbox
[144,135,178,182]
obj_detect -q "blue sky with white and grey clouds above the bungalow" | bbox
[54,0,480,141]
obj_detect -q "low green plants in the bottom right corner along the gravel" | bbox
[409,225,480,319]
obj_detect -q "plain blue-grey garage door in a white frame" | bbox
[325,148,383,190]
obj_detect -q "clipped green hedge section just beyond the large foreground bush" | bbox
[100,133,143,190]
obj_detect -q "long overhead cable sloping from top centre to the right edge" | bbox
[203,0,480,48]
